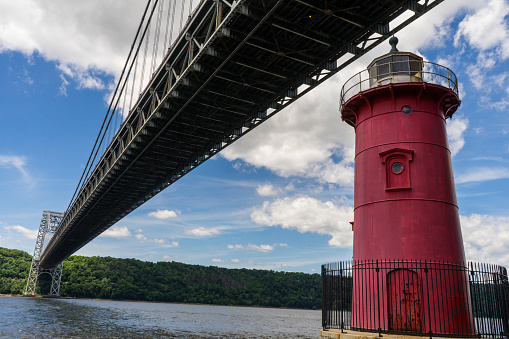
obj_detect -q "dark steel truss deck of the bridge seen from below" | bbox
[39,0,443,268]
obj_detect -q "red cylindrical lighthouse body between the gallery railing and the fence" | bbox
[345,72,465,262]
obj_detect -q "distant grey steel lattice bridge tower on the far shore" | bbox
[23,211,64,297]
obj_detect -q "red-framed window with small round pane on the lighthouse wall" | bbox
[380,148,414,191]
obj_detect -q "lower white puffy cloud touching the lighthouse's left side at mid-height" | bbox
[251,196,353,247]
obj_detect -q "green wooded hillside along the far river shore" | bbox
[0,247,321,309]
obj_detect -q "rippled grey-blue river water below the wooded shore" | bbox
[0,297,321,339]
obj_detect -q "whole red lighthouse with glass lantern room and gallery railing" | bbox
[341,37,474,335]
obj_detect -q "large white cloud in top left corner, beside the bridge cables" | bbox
[0,0,144,73]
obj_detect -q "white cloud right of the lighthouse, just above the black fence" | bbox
[460,214,509,267]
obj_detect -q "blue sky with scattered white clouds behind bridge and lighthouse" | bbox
[0,0,509,273]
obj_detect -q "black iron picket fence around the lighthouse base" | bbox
[322,260,509,338]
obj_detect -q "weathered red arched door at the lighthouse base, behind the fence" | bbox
[387,269,422,332]
